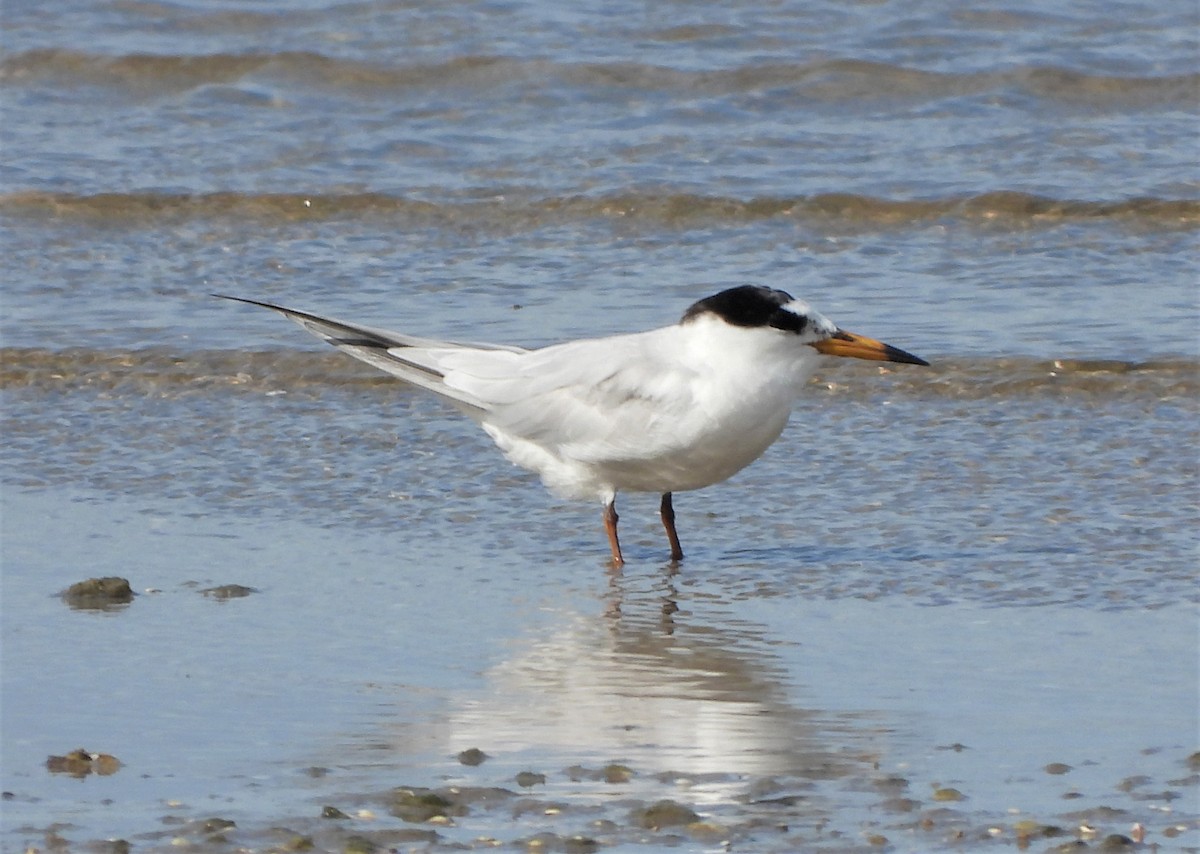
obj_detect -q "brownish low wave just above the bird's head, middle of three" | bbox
[0,191,1200,231]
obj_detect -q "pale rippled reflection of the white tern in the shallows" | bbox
[427,567,878,796]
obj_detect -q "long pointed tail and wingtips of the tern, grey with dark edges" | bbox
[214,294,526,419]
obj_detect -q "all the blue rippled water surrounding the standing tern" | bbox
[0,0,1200,852]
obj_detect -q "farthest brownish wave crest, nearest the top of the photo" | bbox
[0,48,1200,110]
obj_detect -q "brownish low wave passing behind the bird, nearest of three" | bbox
[0,348,1200,401]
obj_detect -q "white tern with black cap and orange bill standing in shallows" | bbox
[215,285,929,566]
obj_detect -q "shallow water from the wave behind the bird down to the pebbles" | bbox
[2,350,1198,850]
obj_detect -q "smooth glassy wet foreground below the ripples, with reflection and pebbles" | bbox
[4,477,1200,852]
